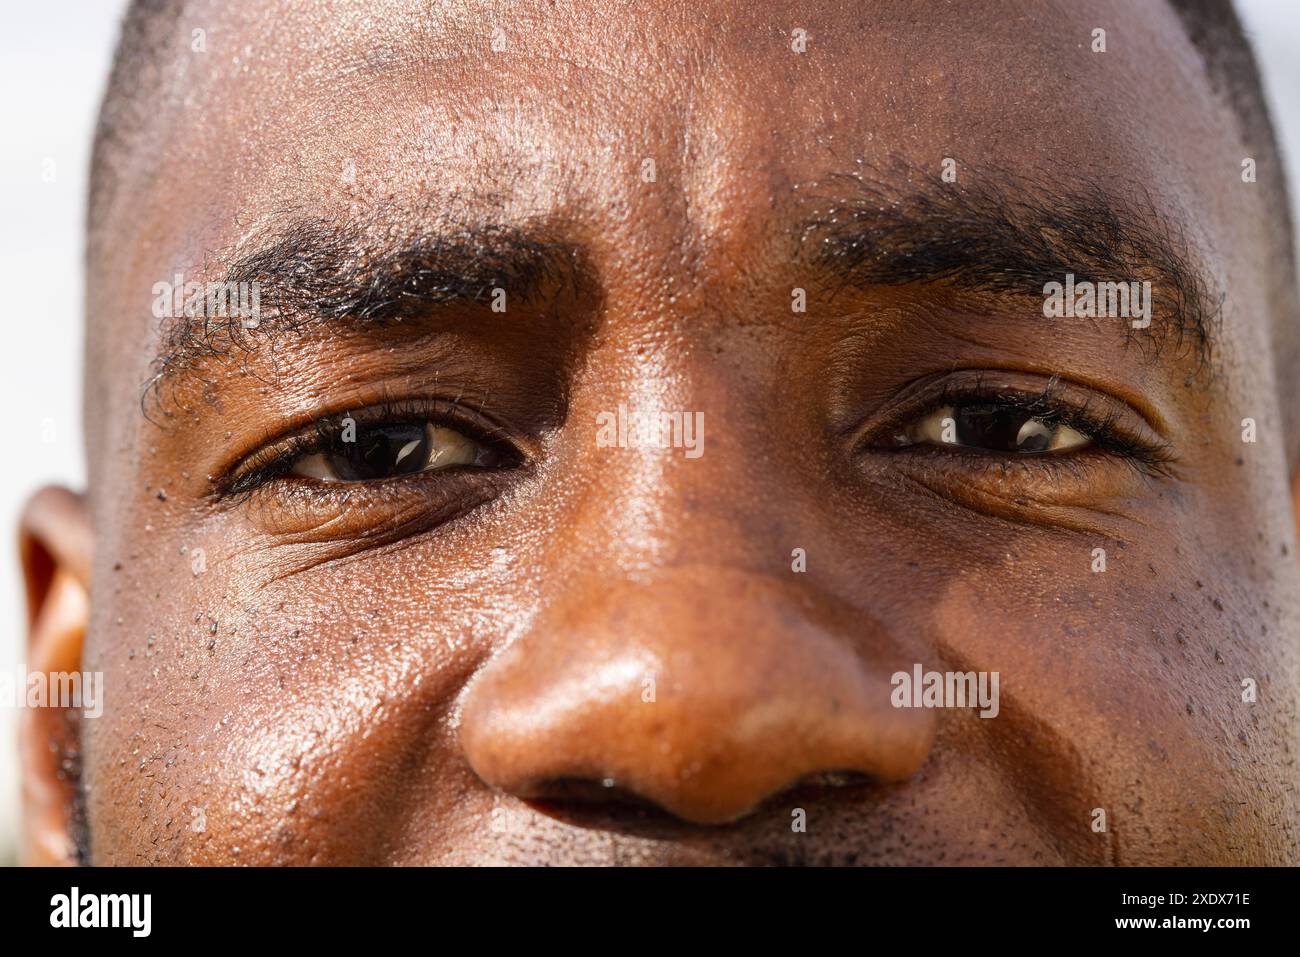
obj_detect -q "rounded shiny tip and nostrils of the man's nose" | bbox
[460,568,935,823]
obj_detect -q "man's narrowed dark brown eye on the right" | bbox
[894,402,1092,454]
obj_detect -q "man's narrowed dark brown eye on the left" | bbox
[292,421,501,482]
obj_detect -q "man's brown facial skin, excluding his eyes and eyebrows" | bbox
[15,0,1300,865]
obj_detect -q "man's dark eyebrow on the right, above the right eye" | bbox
[798,168,1225,376]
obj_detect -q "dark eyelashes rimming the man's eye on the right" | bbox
[883,378,1174,476]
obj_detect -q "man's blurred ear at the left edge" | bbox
[18,486,91,865]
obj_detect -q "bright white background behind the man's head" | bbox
[0,0,1300,863]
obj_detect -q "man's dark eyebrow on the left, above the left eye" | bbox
[146,216,580,395]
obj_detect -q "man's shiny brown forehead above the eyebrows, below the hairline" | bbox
[94,0,1249,408]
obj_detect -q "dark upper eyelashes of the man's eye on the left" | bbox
[220,399,523,499]
